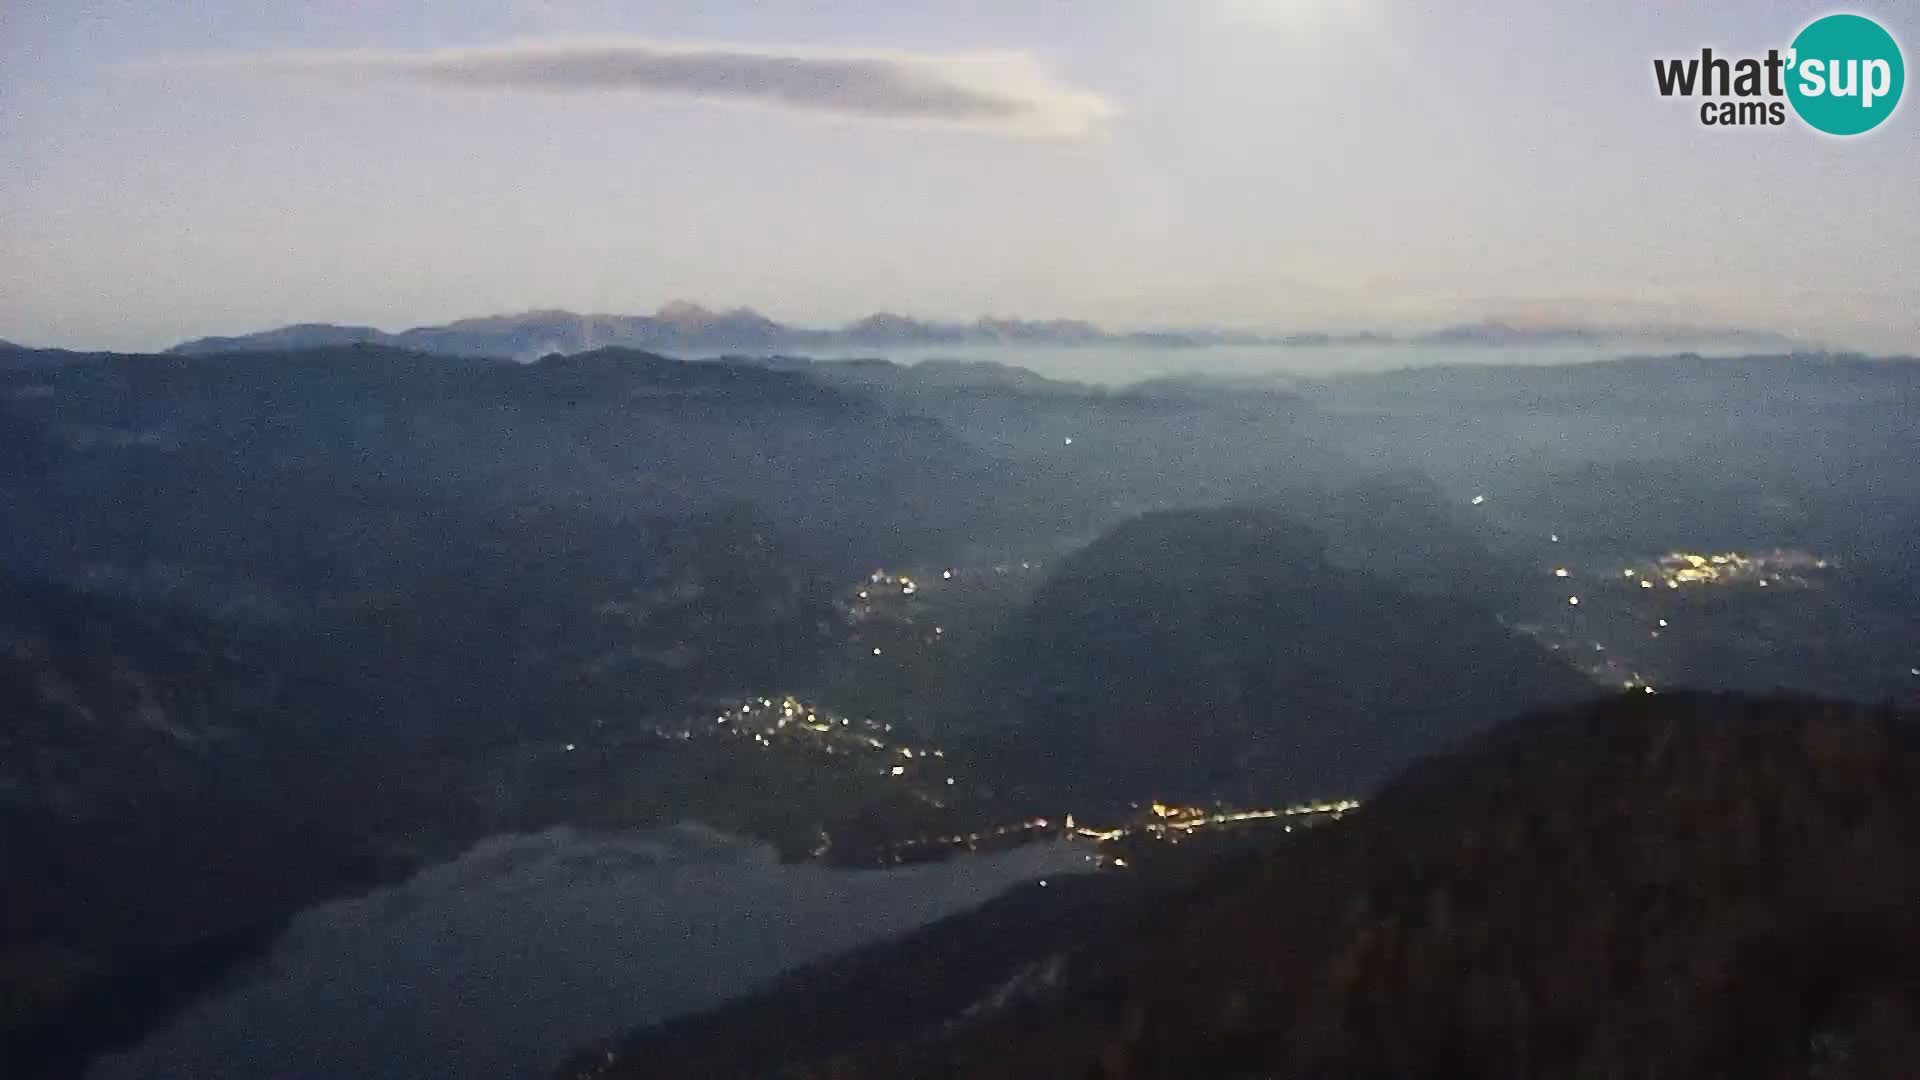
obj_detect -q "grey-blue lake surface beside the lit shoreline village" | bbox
[90,826,1089,1080]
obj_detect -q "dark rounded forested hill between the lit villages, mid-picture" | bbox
[964,507,1592,805]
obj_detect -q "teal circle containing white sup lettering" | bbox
[1788,15,1907,135]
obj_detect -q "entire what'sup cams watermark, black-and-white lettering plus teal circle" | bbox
[1653,15,1907,135]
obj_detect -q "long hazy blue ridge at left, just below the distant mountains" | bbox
[0,346,1085,575]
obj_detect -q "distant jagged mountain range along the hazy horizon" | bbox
[157,300,1791,359]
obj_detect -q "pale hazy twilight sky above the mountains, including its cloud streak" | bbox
[0,0,1920,352]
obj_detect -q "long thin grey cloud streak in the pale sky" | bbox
[165,38,1114,136]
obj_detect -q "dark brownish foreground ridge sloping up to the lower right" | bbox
[563,694,1920,1080]
